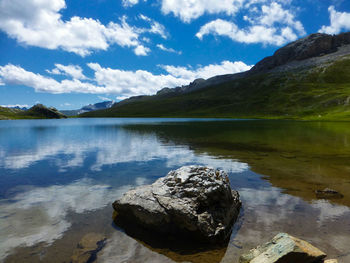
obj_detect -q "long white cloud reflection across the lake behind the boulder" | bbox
[0,120,248,172]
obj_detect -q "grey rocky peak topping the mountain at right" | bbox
[251,32,350,73]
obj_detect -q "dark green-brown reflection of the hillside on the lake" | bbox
[124,121,350,206]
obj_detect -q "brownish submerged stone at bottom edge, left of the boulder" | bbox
[71,233,106,263]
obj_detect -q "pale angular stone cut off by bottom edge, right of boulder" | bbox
[239,233,327,263]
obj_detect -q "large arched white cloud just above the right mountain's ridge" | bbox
[196,2,305,46]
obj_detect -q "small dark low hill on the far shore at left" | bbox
[0,104,67,120]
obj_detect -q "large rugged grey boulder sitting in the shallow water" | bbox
[113,166,241,243]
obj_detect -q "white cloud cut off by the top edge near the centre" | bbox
[161,0,244,23]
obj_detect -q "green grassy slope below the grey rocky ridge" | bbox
[82,56,350,120]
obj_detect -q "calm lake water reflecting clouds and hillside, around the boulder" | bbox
[0,119,350,263]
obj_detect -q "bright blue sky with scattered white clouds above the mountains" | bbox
[0,0,350,110]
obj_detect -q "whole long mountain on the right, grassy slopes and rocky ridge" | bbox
[80,32,350,120]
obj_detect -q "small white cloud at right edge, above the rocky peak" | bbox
[319,6,350,34]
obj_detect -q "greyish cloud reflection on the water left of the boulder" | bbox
[0,178,135,260]
